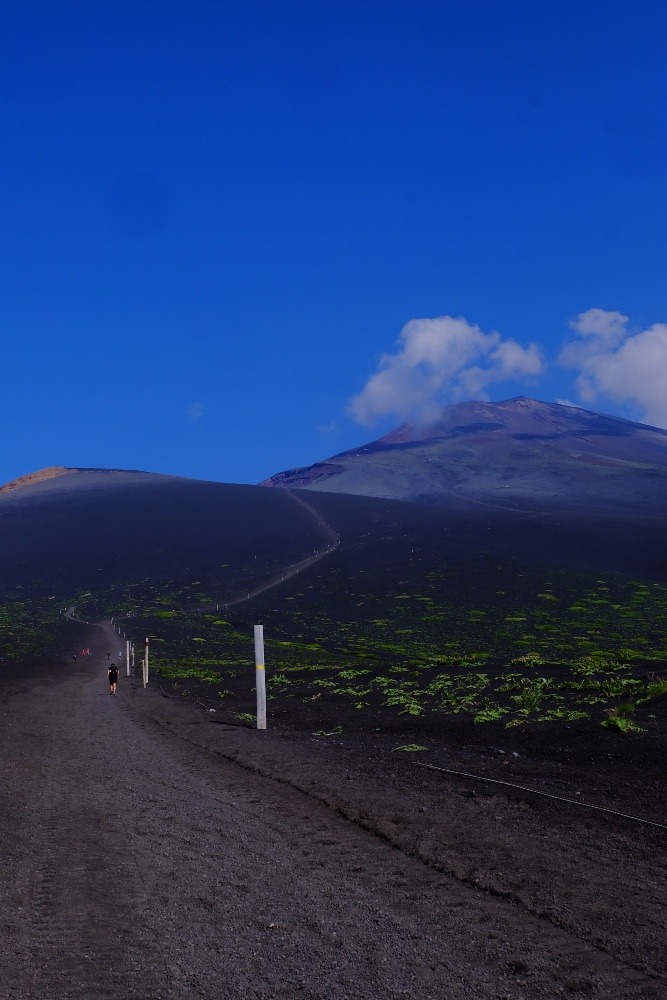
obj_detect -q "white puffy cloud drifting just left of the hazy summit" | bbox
[348,316,544,424]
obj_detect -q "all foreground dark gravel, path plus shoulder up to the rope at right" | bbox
[0,623,667,1000]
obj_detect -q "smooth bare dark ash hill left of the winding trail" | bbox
[0,469,322,596]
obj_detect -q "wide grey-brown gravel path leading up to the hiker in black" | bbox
[0,623,667,1000]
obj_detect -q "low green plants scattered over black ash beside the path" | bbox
[15,558,667,733]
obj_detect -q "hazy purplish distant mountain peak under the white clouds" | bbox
[262,396,667,506]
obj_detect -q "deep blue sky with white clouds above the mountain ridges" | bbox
[0,0,667,482]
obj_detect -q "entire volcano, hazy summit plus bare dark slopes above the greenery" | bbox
[0,398,667,604]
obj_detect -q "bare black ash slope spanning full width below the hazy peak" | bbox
[0,446,667,624]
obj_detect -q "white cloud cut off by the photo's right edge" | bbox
[559,309,667,427]
